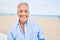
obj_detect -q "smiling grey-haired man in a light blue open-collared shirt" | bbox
[8,3,45,40]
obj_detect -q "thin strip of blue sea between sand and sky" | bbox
[0,14,60,18]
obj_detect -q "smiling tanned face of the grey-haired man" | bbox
[17,4,29,23]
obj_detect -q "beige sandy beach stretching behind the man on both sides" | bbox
[0,16,60,40]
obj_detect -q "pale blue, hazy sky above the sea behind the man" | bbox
[0,0,60,15]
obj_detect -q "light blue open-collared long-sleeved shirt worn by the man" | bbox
[7,20,45,40]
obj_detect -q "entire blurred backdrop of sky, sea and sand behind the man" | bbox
[0,0,60,40]
